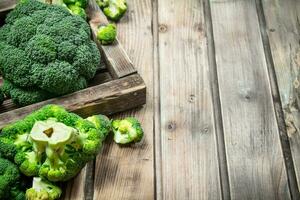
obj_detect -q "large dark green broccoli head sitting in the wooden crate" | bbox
[0,0,100,106]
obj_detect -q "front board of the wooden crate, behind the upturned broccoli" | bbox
[0,74,146,129]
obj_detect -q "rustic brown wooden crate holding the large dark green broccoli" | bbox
[0,0,146,129]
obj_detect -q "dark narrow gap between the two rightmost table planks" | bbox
[255,0,300,199]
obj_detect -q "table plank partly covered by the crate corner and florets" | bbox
[93,0,155,200]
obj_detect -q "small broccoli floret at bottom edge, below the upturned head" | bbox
[26,177,62,200]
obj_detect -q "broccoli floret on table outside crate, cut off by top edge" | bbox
[96,0,127,21]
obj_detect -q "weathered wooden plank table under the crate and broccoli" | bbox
[61,0,300,200]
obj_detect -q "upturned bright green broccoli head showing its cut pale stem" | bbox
[0,105,110,182]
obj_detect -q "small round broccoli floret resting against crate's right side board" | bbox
[97,24,117,45]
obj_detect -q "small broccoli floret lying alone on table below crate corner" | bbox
[112,117,144,144]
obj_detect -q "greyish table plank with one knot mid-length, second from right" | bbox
[211,0,290,199]
